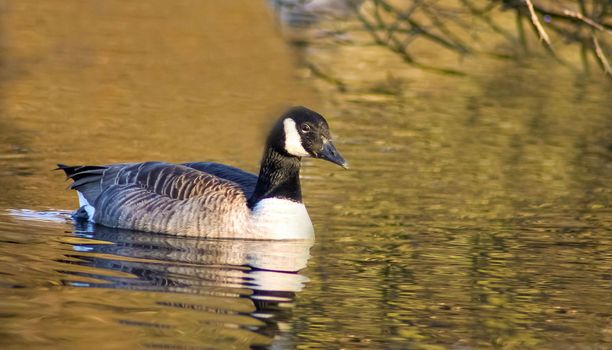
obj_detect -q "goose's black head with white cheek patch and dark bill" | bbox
[268,106,348,169]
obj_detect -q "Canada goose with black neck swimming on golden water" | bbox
[58,107,347,239]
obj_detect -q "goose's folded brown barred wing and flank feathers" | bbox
[59,162,248,236]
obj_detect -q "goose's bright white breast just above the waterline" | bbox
[252,198,314,239]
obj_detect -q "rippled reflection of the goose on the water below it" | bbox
[64,223,313,345]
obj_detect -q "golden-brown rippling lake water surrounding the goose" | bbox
[0,0,612,349]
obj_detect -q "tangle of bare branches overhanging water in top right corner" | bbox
[342,0,612,77]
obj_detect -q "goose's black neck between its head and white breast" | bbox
[249,145,302,208]
